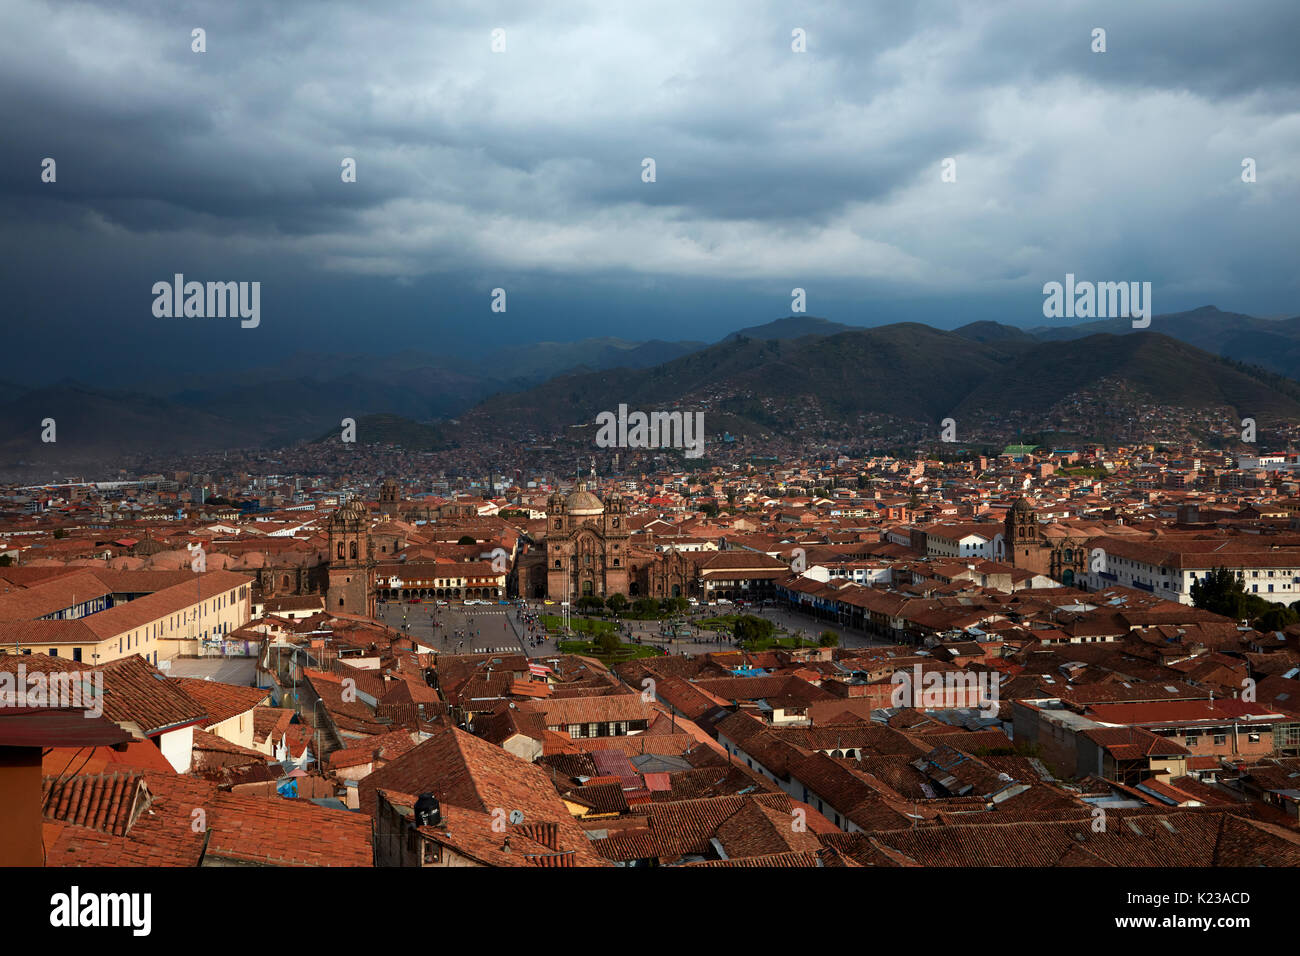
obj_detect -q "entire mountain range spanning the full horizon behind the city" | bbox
[0,306,1300,466]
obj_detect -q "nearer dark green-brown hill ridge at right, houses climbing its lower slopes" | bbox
[462,323,1300,442]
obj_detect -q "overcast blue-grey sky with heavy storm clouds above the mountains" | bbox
[0,0,1300,382]
